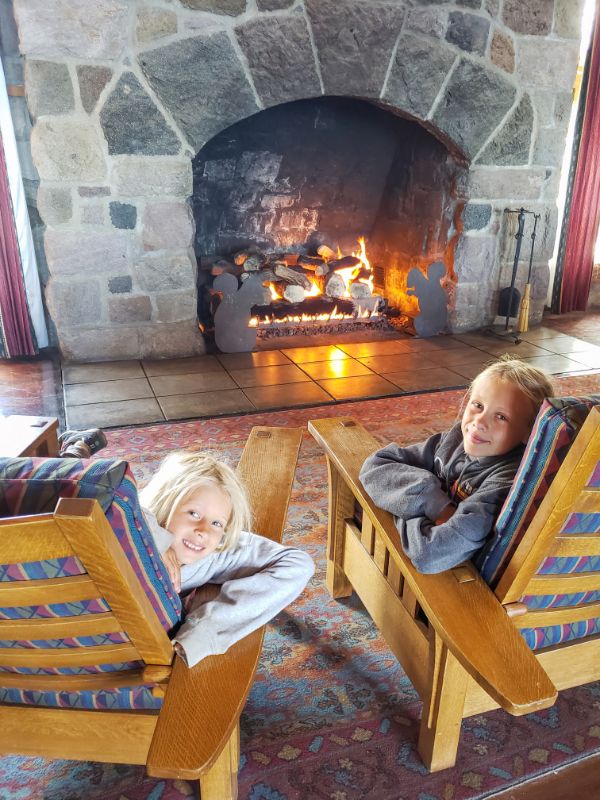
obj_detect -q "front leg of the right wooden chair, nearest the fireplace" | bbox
[325,459,354,598]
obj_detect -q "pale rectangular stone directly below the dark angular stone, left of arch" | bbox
[111,156,193,197]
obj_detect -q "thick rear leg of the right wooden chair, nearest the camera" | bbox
[418,631,469,772]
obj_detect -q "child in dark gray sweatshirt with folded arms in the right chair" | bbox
[360,357,552,573]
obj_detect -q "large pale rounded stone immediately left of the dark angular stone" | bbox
[31,117,106,181]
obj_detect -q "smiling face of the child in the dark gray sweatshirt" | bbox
[461,376,536,458]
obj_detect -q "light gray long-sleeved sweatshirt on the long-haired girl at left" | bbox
[144,509,314,667]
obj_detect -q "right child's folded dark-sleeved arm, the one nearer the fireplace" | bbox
[359,434,449,519]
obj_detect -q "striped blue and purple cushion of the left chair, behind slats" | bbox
[0,458,181,709]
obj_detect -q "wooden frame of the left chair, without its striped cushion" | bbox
[0,427,301,800]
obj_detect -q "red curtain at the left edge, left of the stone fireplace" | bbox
[0,135,36,358]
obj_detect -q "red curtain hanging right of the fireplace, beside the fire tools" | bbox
[560,8,600,313]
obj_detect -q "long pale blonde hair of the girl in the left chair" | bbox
[140,450,252,550]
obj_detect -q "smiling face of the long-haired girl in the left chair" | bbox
[167,485,231,566]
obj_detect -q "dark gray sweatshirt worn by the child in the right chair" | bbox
[360,423,524,573]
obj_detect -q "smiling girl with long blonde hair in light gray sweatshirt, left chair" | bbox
[140,452,314,667]
